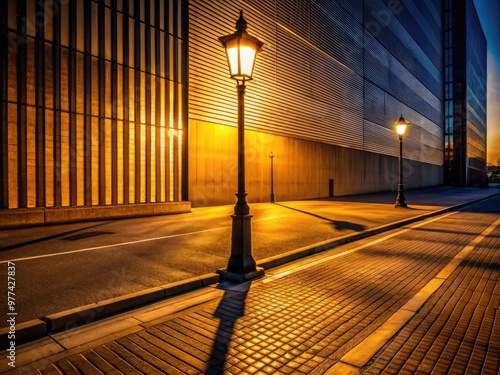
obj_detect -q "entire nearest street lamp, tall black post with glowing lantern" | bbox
[219,11,264,282]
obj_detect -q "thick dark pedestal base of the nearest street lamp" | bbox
[217,214,264,283]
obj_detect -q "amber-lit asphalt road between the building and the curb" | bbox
[0,191,498,326]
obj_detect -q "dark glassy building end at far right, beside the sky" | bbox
[444,0,487,186]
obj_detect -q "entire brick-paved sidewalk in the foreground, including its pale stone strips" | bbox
[0,187,500,374]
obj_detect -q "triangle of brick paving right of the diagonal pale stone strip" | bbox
[366,222,500,375]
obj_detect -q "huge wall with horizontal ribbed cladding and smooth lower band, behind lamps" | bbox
[189,0,443,206]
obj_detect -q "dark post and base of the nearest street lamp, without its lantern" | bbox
[219,81,264,282]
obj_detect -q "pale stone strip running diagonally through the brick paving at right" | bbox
[325,219,500,375]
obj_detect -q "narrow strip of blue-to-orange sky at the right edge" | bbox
[474,0,500,165]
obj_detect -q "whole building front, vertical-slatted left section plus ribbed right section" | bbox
[0,0,450,226]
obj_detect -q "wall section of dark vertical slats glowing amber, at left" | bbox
[0,0,188,212]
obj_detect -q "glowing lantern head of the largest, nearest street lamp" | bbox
[219,10,264,81]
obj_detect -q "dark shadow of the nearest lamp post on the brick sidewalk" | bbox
[205,281,251,375]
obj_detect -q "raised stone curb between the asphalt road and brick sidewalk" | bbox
[0,193,500,349]
